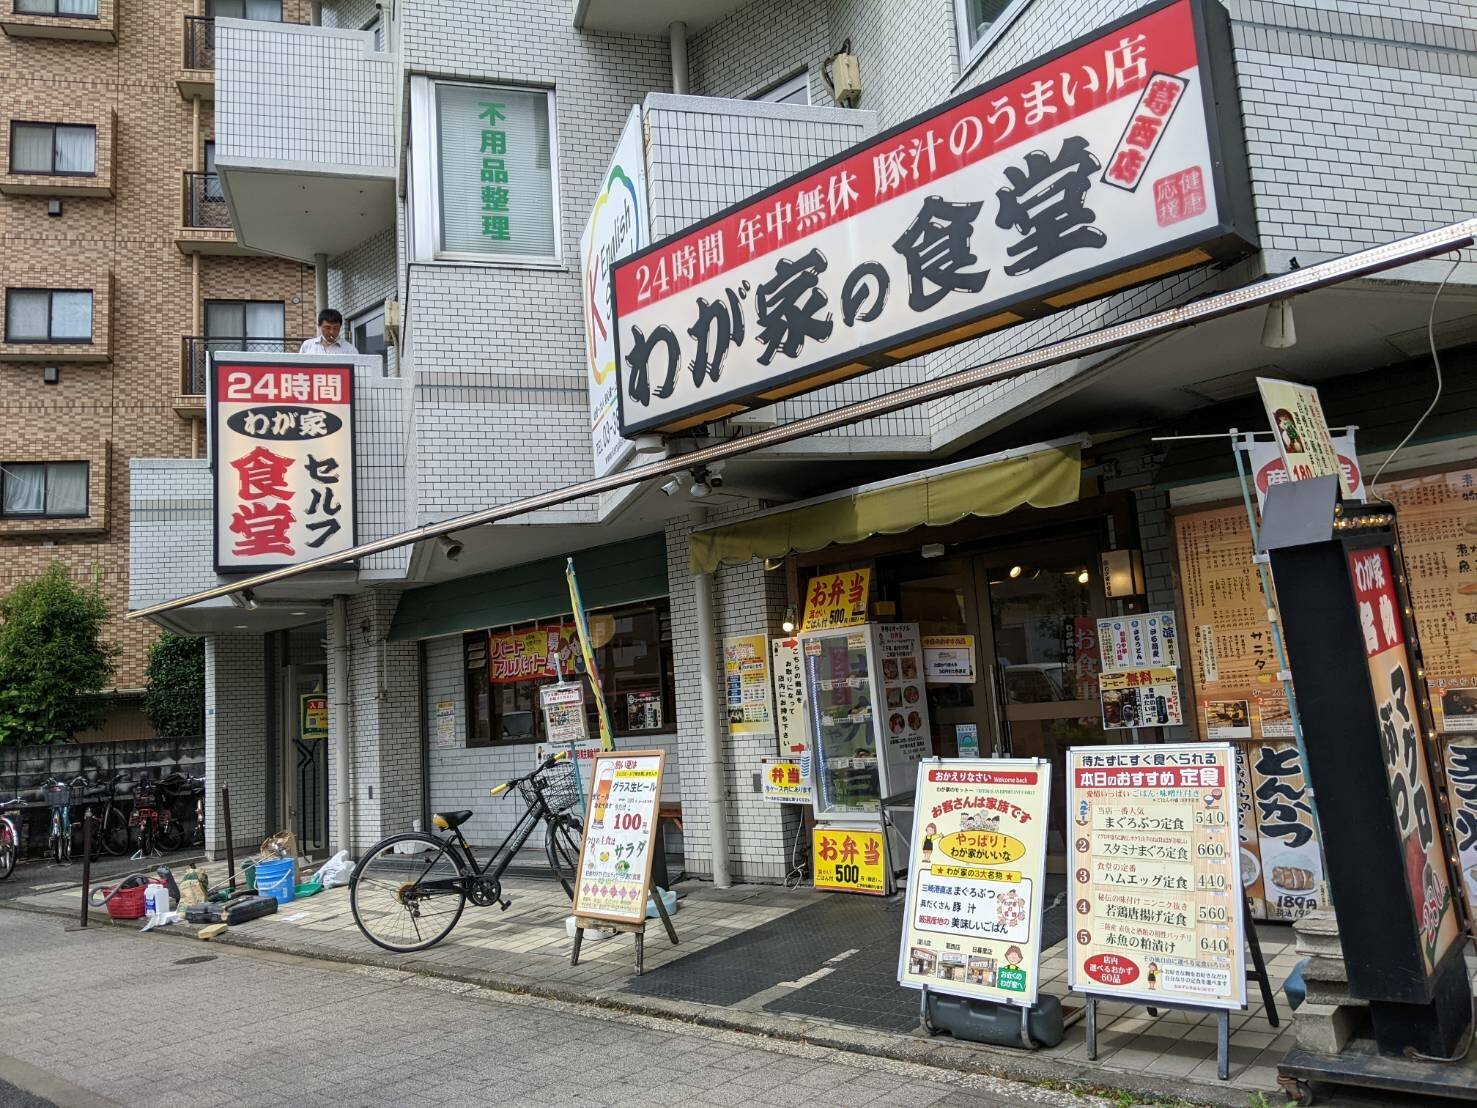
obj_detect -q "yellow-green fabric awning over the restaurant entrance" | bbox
[688,439,1083,573]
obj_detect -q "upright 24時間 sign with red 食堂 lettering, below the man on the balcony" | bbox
[208,358,354,573]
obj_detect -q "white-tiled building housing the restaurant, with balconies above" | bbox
[130,0,1477,900]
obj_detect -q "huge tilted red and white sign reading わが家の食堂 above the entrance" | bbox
[614,0,1250,436]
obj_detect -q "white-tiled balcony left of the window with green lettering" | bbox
[214,19,397,261]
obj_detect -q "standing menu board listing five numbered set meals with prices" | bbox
[1066,743,1247,1008]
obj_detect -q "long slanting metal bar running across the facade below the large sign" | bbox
[126,219,1477,619]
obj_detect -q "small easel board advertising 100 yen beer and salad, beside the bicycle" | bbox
[575,750,666,923]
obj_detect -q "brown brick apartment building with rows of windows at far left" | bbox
[0,0,316,737]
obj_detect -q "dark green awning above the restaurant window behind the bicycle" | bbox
[390,535,668,641]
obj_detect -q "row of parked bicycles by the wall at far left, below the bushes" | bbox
[0,773,205,880]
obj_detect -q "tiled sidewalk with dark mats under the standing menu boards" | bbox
[7,867,1295,1108]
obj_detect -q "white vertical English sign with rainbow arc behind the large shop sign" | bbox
[579,105,651,477]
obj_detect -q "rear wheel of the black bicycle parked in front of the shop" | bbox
[349,832,468,954]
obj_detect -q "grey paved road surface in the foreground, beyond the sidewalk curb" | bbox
[0,912,1106,1108]
